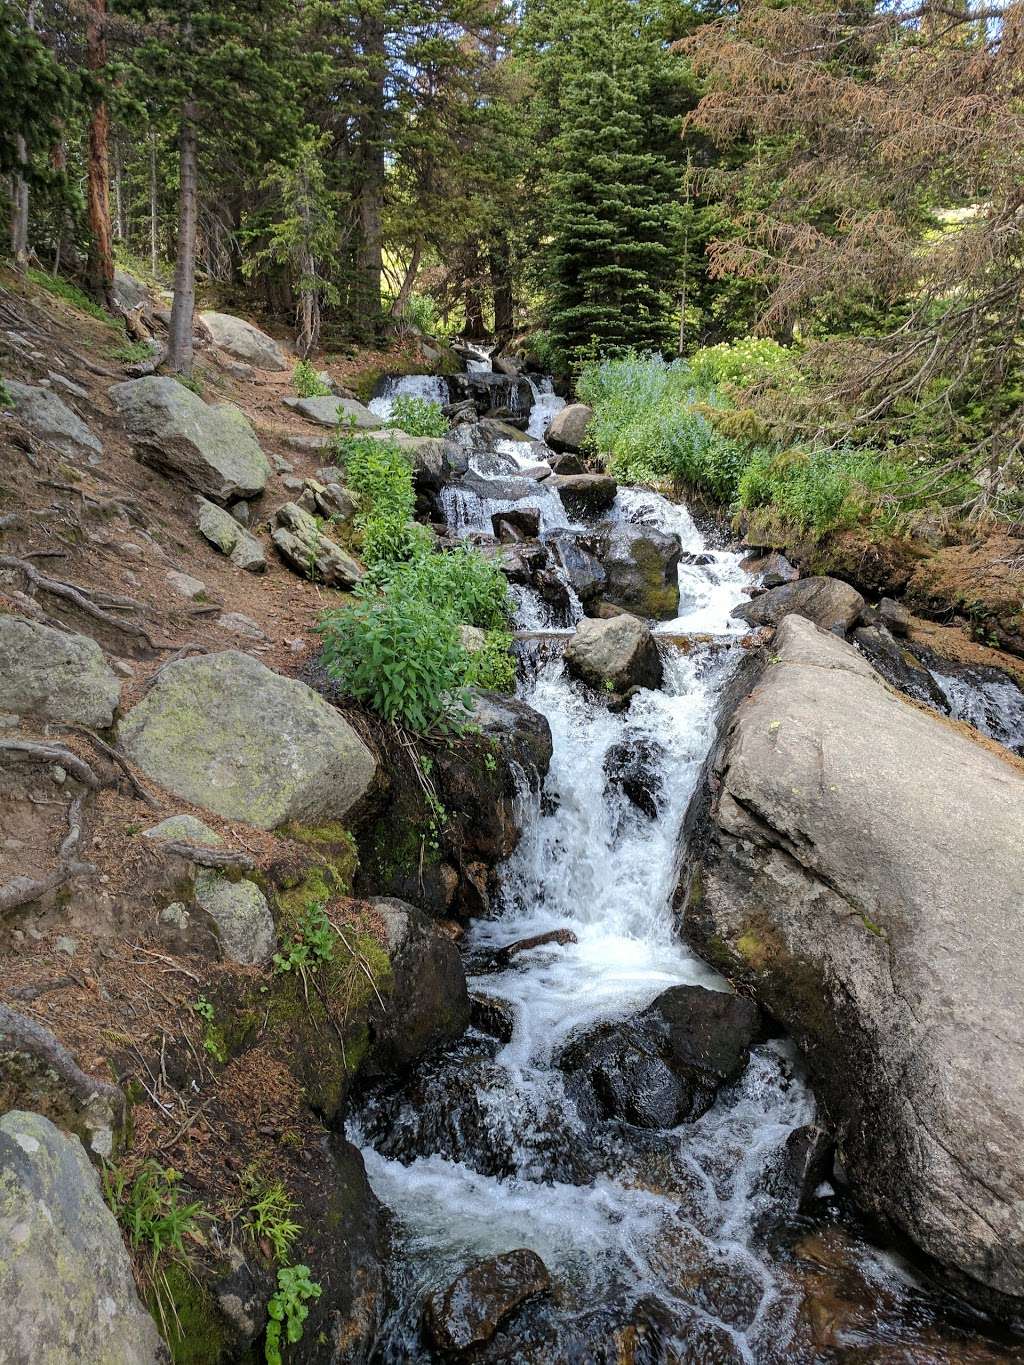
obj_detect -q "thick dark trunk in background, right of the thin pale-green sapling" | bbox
[354,15,386,341]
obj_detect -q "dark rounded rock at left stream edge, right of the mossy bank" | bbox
[366,897,470,1076]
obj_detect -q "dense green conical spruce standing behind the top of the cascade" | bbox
[542,0,684,366]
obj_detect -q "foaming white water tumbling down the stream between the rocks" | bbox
[351,365,830,1361]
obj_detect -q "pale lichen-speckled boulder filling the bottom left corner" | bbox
[0,1110,169,1365]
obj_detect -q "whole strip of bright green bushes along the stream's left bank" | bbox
[319,438,511,733]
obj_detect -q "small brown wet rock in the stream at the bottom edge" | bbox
[425,1249,550,1351]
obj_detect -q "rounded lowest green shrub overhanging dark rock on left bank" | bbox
[318,591,468,733]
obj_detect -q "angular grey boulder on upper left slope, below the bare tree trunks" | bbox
[111,374,270,502]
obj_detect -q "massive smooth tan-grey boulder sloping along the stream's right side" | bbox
[680,616,1024,1313]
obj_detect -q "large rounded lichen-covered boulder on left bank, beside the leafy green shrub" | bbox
[119,650,375,830]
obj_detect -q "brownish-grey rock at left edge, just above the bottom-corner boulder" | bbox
[0,1005,127,1157]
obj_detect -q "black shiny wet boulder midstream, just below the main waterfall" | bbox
[557,986,759,1129]
